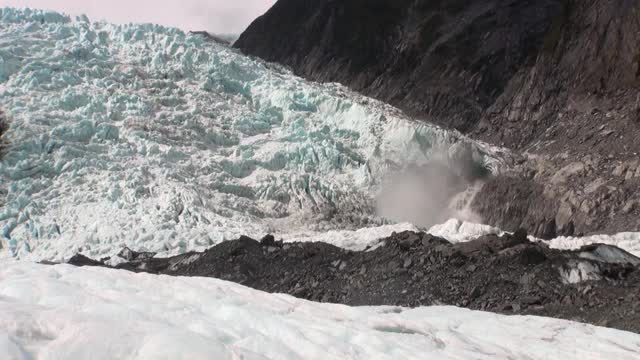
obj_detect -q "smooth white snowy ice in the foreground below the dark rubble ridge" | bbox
[0,261,640,360]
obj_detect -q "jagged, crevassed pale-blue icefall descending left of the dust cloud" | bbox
[0,8,498,259]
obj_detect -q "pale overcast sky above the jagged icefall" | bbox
[0,0,276,33]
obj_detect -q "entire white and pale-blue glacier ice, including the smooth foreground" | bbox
[0,8,640,360]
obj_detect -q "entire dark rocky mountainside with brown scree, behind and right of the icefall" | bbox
[235,0,640,237]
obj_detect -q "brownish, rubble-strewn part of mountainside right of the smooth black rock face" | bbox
[472,0,640,236]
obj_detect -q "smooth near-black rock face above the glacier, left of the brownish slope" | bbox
[234,0,564,131]
